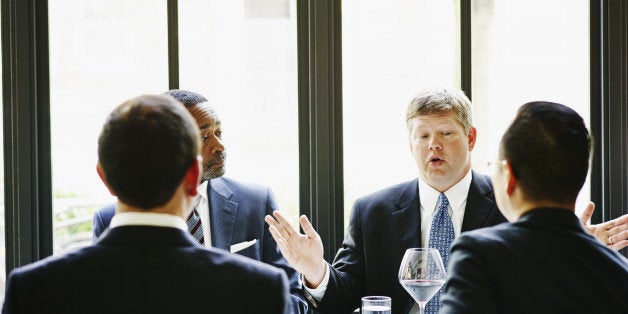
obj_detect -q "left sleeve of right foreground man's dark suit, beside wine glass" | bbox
[439,235,500,314]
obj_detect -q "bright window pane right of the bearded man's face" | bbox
[179,0,299,223]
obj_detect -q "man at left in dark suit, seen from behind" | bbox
[3,95,289,313]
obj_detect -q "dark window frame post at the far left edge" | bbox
[2,0,53,273]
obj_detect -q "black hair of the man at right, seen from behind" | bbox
[500,102,592,203]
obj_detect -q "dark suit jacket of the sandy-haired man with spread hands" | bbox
[309,172,506,313]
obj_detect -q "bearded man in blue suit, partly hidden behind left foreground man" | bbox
[92,90,307,313]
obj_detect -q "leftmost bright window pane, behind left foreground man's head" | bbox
[49,0,168,253]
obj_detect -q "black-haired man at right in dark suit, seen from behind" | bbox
[441,102,628,313]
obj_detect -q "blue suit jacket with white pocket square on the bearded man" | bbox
[92,177,307,313]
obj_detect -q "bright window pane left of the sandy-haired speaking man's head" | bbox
[342,0,460,231]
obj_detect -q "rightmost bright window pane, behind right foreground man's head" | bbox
[472,0,599,210]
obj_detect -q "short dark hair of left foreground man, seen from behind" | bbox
[98,95,200,209]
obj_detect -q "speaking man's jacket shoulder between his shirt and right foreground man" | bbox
[462,171,497,232]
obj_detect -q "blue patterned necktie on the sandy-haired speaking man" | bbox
[425,193,455,314]
